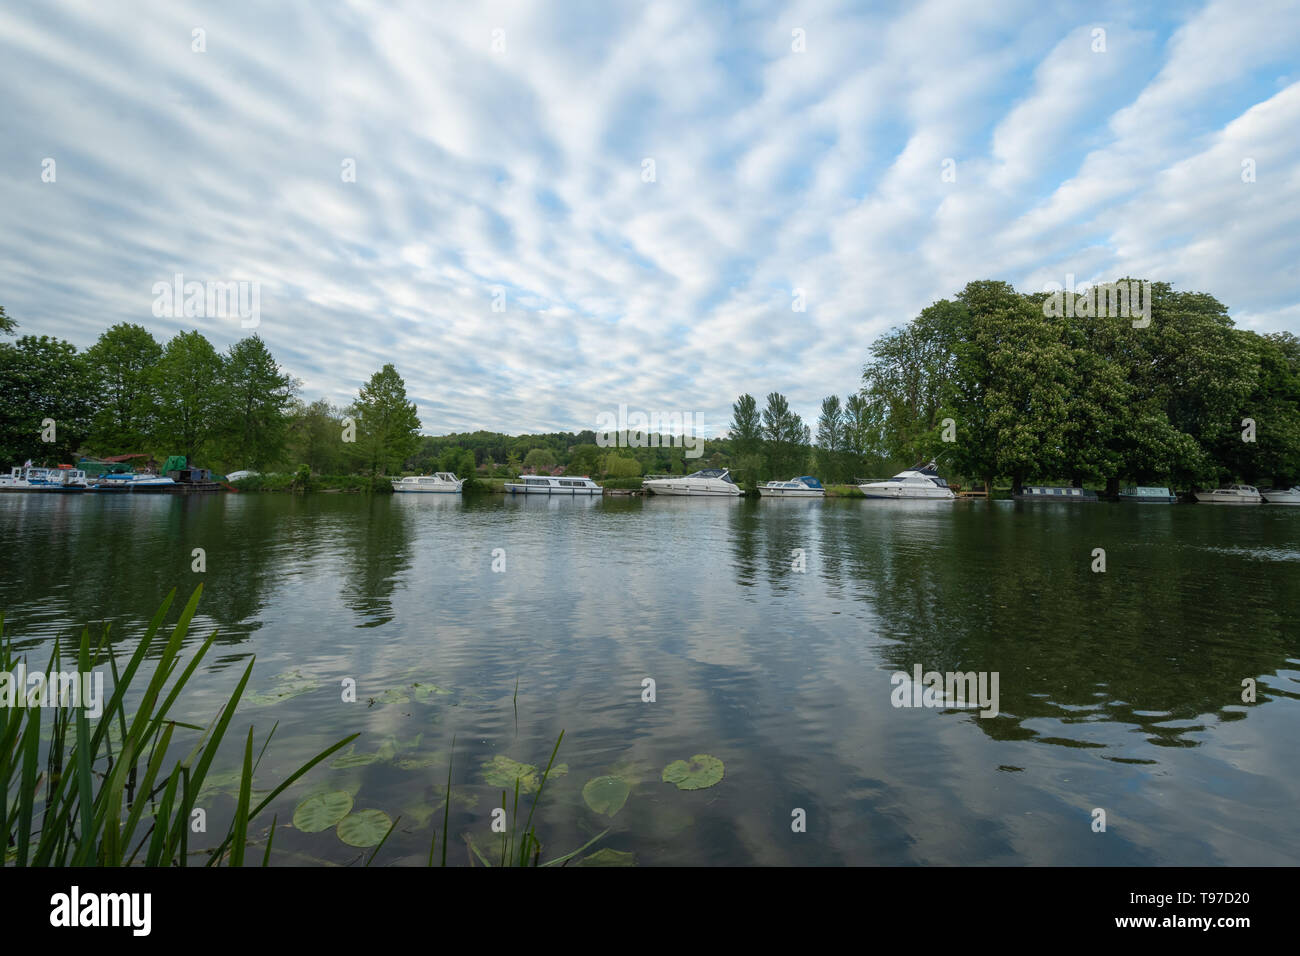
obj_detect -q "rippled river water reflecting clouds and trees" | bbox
[0,494,1300,865]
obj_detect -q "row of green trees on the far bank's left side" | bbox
[0,308,420,475]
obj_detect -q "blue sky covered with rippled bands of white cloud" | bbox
[0,0,1300,434]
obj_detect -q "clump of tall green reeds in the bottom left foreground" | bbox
[0,584,359,866]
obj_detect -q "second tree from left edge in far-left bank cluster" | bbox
[86,323,163,454]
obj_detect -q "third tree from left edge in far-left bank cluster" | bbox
[153,330,222,463]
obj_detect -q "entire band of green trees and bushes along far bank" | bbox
[0,281,1300,498]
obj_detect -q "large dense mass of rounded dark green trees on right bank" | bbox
[845,280,1300,488]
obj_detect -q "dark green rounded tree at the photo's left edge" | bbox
[0,336,96,462]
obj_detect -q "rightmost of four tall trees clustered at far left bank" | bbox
[220,336,298,471]
